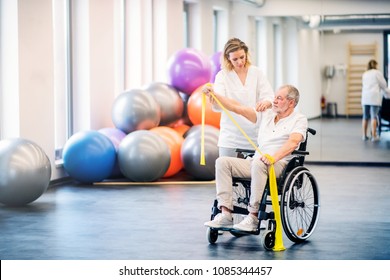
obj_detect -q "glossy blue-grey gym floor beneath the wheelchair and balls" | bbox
[0,117,390,260]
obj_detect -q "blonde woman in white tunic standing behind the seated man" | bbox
[203,38,274,157]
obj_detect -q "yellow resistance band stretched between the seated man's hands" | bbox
[200,87,286,251]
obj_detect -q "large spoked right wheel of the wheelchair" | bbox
[280,166,320,243]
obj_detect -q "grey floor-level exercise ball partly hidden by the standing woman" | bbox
[181,125,219,180]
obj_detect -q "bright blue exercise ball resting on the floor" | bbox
[62,130,116,183]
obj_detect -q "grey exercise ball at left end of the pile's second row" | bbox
[111,89,160,134]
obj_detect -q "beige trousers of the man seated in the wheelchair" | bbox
[215,157,287,213]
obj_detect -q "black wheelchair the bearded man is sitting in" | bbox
[207,128,320,250]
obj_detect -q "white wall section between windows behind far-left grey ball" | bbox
[16,0,55,177]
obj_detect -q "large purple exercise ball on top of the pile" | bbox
[168,48,211,95]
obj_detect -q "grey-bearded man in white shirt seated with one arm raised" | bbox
[204,85,308,232]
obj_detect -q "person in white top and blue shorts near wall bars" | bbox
[362,59,390,142]
